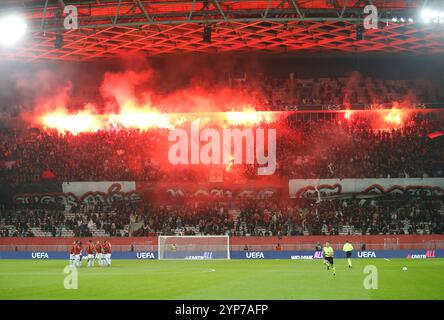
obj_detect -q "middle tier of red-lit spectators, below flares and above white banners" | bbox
[0,109,444,185]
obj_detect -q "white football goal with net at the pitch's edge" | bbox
[157,236,230,260]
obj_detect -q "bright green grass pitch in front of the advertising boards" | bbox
[0,259,444,300]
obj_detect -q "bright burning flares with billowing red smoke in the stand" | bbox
[28,55,416,134]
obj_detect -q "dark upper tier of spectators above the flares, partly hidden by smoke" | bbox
[67,71,444,112]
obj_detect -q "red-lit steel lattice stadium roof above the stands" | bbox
[0,0,444,61]
